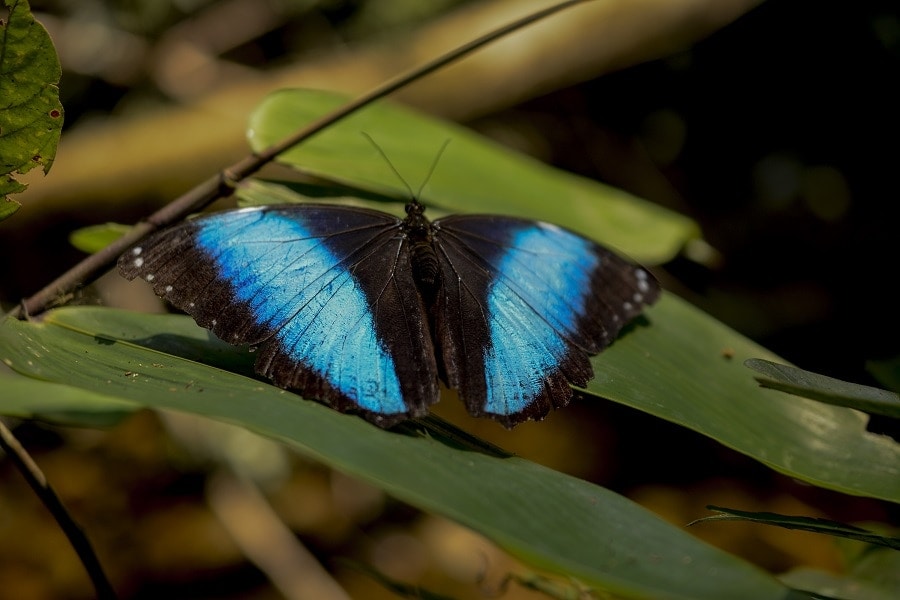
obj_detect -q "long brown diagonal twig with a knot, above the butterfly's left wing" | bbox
[9,0,590,318]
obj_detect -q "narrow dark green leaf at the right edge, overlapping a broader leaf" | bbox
[744,358,900,419]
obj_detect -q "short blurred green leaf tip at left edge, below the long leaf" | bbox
[0,375,140,427]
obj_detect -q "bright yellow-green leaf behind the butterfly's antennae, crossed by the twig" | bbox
[248,90,699,264]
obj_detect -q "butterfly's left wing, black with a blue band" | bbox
[119,204,439,426]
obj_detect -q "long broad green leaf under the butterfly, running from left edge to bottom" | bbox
[0,308,802,600]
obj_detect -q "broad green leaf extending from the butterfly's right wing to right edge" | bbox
[587,294,900,502]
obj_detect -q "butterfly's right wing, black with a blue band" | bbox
[434,215,659,427]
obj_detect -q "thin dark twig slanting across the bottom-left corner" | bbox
[0,420,116,600]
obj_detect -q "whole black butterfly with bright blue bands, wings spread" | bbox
[118,197,660,428]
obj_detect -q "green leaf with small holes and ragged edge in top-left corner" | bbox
[0,0,63,210]
